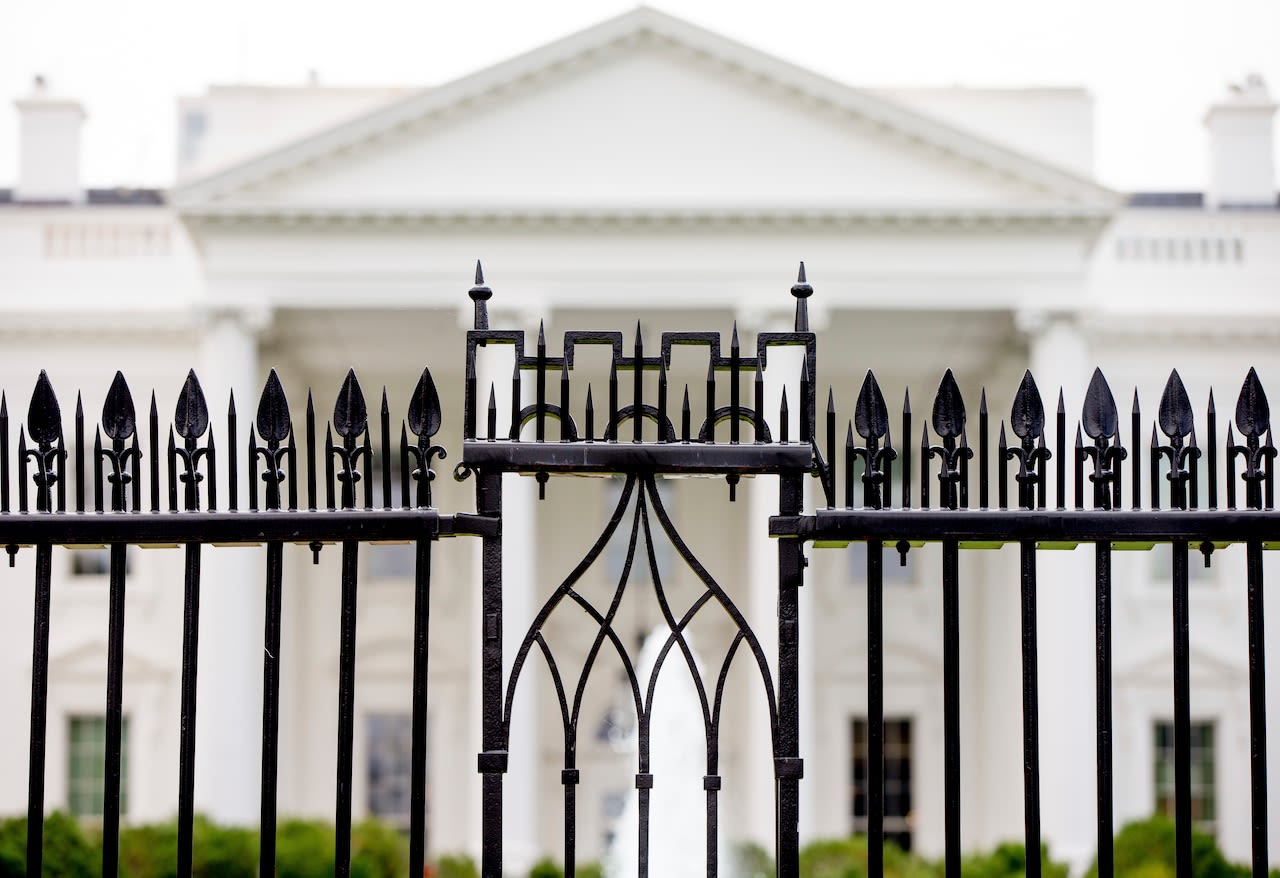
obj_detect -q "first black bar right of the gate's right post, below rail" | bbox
[867,540,884,878]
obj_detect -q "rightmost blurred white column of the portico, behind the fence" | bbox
[1009,312,1097,874]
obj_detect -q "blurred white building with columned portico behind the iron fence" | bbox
[0,9,1280,865]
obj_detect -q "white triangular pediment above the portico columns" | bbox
[174,9,1115,218]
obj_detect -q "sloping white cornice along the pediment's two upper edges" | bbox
[172,6,1121,209]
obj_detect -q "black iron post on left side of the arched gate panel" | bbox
[476,470,507,878]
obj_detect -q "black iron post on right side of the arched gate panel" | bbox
[773,471,805,878]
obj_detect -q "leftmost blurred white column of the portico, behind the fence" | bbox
[195,311,270,826]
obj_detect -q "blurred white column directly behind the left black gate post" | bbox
[472,330,545,874]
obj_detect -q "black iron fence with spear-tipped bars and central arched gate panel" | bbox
[0,266,1280,877]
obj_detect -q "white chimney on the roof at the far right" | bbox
[1204,74,1276,207]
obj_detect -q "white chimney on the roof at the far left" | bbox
[14,77,84,204]
